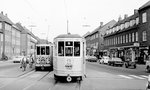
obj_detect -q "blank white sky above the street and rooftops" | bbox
[0,0,148,42]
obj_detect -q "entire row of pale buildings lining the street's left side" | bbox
[0,12,37,60]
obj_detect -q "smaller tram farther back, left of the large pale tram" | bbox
[35,44,53,71]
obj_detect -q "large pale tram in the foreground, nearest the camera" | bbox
[53,34,86,82]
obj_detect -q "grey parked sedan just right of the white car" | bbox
[108,57,123,67]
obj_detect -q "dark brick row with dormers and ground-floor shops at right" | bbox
[104,1,150,63]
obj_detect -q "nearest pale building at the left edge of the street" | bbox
[0,12,21,59]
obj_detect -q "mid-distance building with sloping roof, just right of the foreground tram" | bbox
[84,20,116,55]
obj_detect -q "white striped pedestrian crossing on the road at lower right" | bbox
[118,75,148,79]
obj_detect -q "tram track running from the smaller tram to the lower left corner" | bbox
[0,71,50,90]
